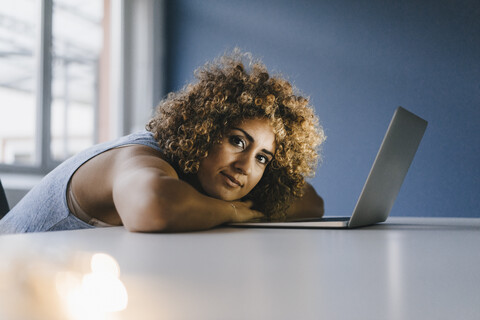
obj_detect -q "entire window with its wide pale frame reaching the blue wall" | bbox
[0,0,166,180]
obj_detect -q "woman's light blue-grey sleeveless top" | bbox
[0,131,161,234]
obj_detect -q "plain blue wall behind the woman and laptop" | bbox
[163,0,480,217]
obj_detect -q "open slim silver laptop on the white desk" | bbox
[229,107,427,228]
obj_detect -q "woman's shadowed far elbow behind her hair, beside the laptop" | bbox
[287,183,325,220]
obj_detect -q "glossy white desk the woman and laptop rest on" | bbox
[0,218,480,320]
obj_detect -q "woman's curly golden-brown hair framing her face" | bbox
[146,49,325,219]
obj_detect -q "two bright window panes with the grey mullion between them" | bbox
[0,0,109,173]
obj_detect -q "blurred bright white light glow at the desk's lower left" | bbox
[56,253,128,320]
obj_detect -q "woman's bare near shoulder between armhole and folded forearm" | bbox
[71,145,178,225]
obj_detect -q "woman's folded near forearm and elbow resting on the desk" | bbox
[112,149,263,232]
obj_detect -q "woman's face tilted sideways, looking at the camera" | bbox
[197,119,275,201]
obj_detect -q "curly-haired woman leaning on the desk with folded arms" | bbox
[0,50,324,233]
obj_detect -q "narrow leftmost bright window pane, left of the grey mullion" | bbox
[0,0,38,164]
